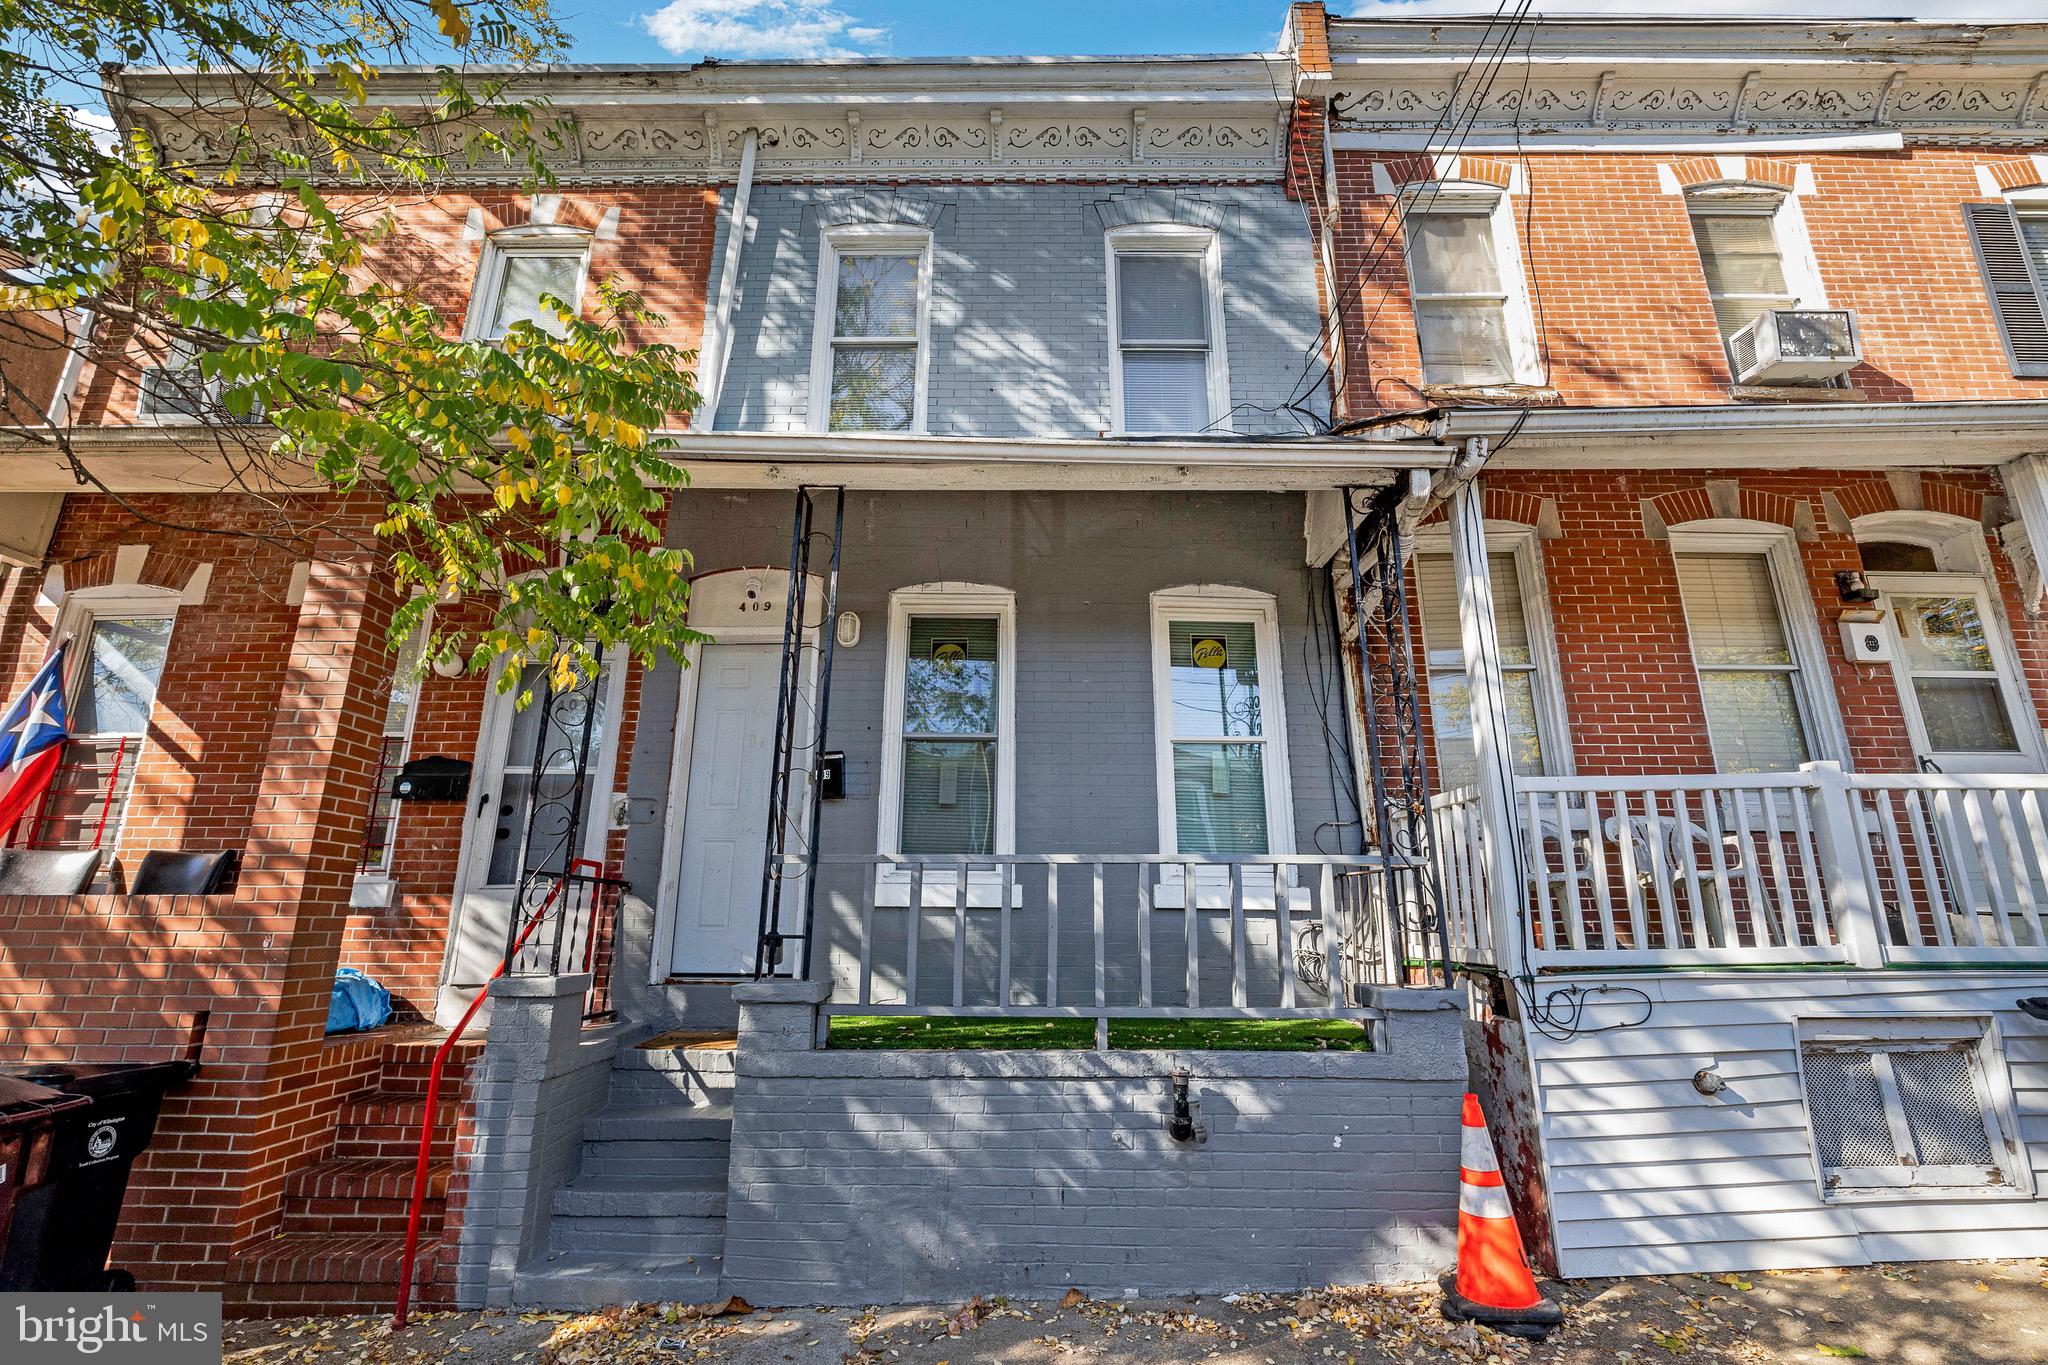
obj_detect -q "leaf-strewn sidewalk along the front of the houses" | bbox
[216,1261,2048,1365]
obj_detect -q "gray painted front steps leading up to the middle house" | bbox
[512,1044,733,1308]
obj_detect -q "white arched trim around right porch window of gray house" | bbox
[1151,583,1294,853]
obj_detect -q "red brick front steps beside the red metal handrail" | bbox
[223,1029,483,1316]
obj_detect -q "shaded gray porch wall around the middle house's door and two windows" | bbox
[623,491,1358,1017]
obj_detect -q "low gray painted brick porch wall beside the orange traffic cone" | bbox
[723,984,1464,1304]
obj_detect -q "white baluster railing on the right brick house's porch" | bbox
[1434,763,2048,968]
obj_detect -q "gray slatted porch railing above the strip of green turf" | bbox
[786,853,1397,1046]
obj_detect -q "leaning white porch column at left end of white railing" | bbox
[1450,458,1528,974]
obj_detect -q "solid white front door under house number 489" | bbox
[670,645,782,976]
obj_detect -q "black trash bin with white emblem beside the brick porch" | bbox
[0,1060,199,1293]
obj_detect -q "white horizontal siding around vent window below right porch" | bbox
[1528,970,2048,1277]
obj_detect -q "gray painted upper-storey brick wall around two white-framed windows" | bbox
[713,184,1325,436]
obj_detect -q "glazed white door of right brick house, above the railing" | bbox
[1870,573,2042,774]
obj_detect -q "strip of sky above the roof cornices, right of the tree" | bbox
[557,0,2048,61]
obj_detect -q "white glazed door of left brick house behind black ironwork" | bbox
[438,661,621,1023]
